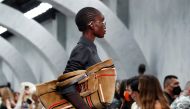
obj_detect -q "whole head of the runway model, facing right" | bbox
[75,7,106,40]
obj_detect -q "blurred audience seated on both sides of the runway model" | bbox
[0,72,187,109]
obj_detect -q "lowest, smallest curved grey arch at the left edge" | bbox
[0,36,37,83]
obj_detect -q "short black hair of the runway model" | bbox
[75,7,101,32]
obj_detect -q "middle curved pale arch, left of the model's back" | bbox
[0,4,67,74]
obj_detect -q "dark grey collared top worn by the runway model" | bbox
[60,36,101,94]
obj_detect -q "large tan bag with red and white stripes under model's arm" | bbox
[36,60,116,109]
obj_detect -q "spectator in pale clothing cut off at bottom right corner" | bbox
[171,81,190,109]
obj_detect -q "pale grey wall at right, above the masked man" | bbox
[129,0,190,86]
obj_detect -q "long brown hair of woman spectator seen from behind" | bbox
[138,75,169,109]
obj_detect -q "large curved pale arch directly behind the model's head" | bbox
[41,0,146,78]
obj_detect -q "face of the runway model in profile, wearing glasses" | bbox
[93,14,106,38]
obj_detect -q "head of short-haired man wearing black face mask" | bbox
[164,75,181,97]
